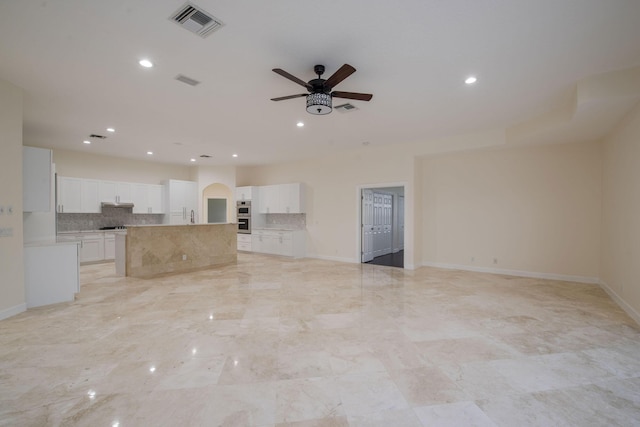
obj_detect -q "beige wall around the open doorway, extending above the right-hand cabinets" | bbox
[236,147,415,268]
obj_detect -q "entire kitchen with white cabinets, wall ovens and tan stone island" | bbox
[23,146,306,307]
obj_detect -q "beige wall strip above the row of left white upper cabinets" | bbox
[53,150,191,184]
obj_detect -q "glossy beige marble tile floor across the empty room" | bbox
[0,254,640,427]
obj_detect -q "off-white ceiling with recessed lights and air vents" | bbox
[0,0,640,165]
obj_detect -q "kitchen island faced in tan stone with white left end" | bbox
[116,224,238,278]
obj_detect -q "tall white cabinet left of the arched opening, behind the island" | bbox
[164,179,198,225]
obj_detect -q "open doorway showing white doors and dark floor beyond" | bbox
[360,186,404,268]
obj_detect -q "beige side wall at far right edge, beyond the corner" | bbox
[600,104,640,322]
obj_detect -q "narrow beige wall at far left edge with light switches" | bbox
[0,80,26,319]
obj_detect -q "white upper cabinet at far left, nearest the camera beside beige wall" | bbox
[22,147,51,212]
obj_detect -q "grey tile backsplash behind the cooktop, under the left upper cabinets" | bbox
[56,207,164,233]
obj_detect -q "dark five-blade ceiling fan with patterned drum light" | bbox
[271,64,373,115]
